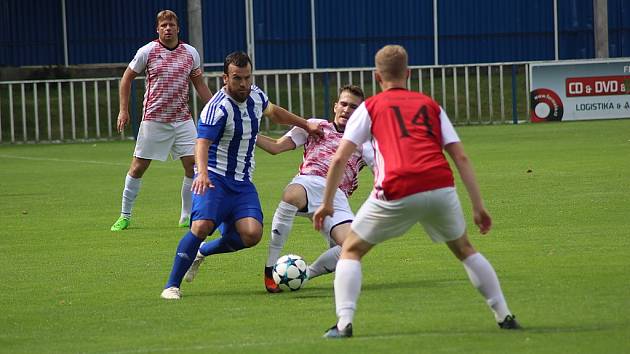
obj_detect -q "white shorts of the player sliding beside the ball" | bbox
[291,175,354,242]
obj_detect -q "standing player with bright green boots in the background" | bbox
[111,10,212,231]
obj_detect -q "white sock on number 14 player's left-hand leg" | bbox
[335,259,362,328]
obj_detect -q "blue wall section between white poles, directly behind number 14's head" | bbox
[314,0,433,68]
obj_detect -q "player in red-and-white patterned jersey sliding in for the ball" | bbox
[256,85,374,293]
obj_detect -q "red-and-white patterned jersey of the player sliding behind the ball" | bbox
[285,118,374,196]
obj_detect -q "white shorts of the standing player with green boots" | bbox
[133,119,197,161]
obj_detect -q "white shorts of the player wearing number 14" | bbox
[351,187,466,244]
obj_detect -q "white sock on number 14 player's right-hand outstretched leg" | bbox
[464,253,511,322]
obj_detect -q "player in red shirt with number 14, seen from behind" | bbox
[313,45,520,338]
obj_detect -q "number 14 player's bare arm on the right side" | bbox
[444,142,492,235]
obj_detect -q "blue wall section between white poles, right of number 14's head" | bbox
[438,0,554,64]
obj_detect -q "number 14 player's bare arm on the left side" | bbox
[313,139,357,231]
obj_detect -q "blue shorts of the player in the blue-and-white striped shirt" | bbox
[190,171,263,230]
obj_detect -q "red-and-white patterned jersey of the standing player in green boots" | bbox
[129,39,202,123]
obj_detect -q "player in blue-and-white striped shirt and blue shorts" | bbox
[161,52,322,300]
